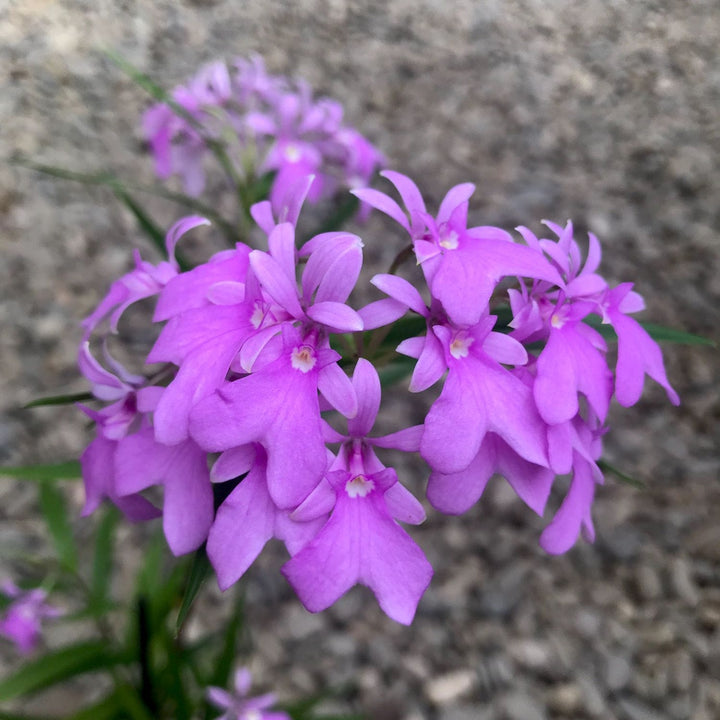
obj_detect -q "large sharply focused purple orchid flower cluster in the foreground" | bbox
[79,159,679,624]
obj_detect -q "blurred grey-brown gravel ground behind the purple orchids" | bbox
[0,0,720,720]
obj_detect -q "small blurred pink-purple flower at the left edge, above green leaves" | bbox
[0,580,63,655]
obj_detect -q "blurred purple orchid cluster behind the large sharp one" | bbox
[143,56,385,207]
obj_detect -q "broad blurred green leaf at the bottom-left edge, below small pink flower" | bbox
[0,641,126,702]
